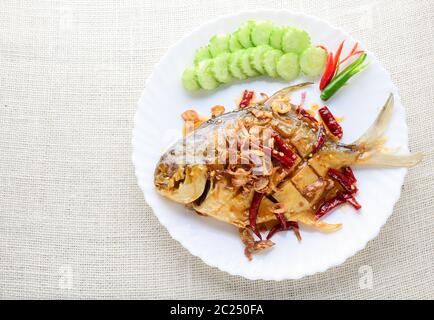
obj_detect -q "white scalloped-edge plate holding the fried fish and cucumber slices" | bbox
[132,10,408,280]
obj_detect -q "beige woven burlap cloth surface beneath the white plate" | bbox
[0,0,434,299]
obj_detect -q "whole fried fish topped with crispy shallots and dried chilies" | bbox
[154,83,422,255]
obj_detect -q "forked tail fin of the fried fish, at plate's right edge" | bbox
[349,94,423,167]
